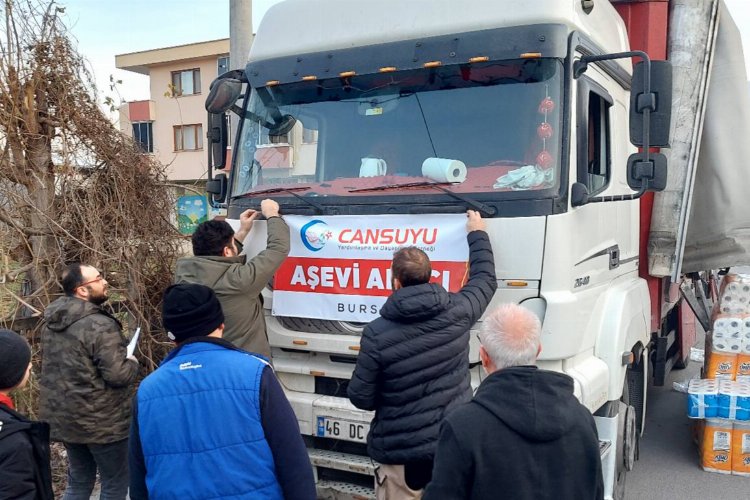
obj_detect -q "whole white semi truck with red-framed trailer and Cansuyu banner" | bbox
[206,0,750,498]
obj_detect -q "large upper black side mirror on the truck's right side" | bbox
[630,61,672,148]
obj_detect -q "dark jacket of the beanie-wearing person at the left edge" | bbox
[0,403,54,500]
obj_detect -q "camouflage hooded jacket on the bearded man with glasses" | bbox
[39,296,138,444]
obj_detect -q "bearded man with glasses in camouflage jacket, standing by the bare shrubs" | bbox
[40,263,138,500]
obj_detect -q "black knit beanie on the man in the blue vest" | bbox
[162,283,224,343]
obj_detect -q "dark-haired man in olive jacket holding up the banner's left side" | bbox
[175,200,289,360]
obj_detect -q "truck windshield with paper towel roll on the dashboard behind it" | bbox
[232,58,562,203]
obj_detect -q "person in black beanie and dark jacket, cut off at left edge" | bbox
[0,329,54,500]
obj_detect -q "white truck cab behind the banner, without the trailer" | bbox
[207,0,670,498]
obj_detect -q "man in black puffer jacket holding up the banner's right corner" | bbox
[348,210,497,500]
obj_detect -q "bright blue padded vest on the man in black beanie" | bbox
[138,342,283,499]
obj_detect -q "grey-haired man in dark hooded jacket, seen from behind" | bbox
[424,304,604,500]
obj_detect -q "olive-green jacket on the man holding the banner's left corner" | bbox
[175,217,289,359]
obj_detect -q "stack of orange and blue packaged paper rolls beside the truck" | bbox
[688,274,750,476]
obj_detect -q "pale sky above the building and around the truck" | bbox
[57,0,750,105]
